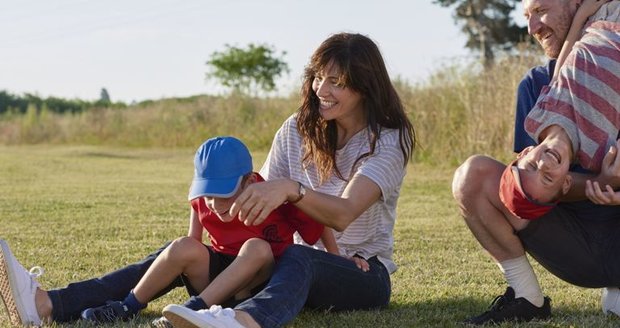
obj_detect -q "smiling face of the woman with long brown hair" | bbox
[312,64,364,122]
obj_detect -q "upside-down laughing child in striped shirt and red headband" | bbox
[499,0,620,220]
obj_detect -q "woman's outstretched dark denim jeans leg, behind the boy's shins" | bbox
[48,243,184,322]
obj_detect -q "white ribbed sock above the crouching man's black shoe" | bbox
[497,255,545,307]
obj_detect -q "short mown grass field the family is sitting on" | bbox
[0,146,620,327]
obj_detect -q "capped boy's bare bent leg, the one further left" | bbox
[133,237,210,304]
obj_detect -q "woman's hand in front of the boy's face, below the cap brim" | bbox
[230,179,299,226]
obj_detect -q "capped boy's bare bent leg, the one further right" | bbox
[196,238,274,305]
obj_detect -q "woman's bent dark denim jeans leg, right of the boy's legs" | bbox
[235,245,391,328]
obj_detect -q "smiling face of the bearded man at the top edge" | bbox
[523,0,577,58]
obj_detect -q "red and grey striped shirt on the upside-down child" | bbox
[525,19,620,172]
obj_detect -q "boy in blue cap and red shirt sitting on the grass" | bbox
[82,137,338,327]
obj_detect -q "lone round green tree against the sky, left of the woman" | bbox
[207,43,289,93]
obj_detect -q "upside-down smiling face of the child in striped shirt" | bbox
[517,143,572,203]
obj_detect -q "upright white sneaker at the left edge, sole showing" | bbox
[0,239,43,326]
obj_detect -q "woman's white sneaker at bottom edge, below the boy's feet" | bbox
[163,304,244,328]
